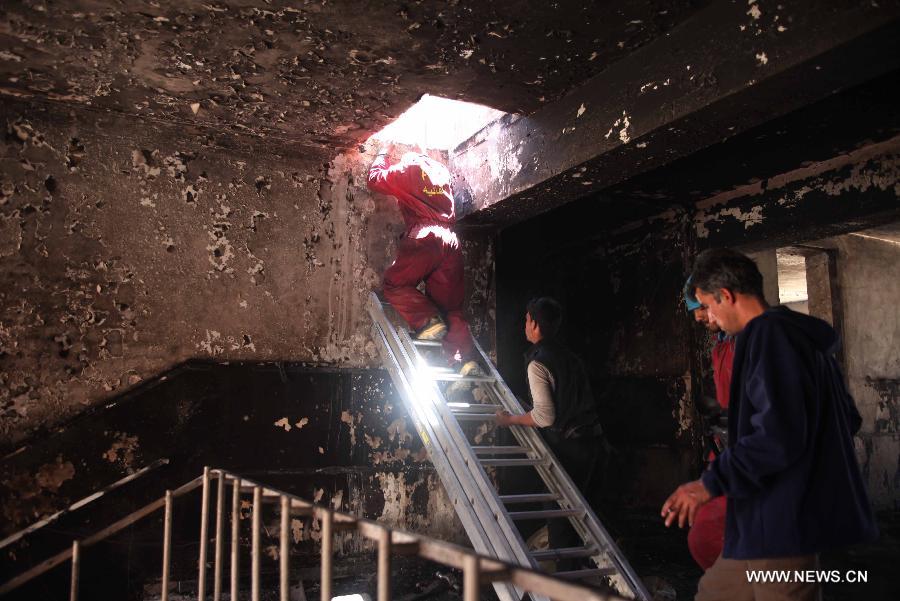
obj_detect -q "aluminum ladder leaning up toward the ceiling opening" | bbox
[368,292,651,601]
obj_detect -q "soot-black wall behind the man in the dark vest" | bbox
[497,203,699,513]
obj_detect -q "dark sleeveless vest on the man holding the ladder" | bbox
[525,340,601,438]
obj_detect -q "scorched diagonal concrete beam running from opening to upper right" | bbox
[451,0,900,226]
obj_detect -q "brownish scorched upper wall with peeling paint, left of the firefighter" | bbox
[0,101,492,449]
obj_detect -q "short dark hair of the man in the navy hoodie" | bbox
[691,248,765,301]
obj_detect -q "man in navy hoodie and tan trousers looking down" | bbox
[662,249,878,601]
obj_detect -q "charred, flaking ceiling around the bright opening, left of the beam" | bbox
[0,0,706,155]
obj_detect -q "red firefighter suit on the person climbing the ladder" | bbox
[368,152,473,361]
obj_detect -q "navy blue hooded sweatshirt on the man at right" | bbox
[703,307,878,559]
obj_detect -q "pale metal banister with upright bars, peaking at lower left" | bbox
[0,468,621,601]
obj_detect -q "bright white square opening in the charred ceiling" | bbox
[369,94,506,150]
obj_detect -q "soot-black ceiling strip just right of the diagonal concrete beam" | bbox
[492,71,900,246]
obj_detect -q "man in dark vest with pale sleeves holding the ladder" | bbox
[495,297,603,571]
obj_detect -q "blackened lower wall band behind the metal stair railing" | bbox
[0,362,466,599]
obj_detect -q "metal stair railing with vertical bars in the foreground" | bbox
[0,467,625,601]
